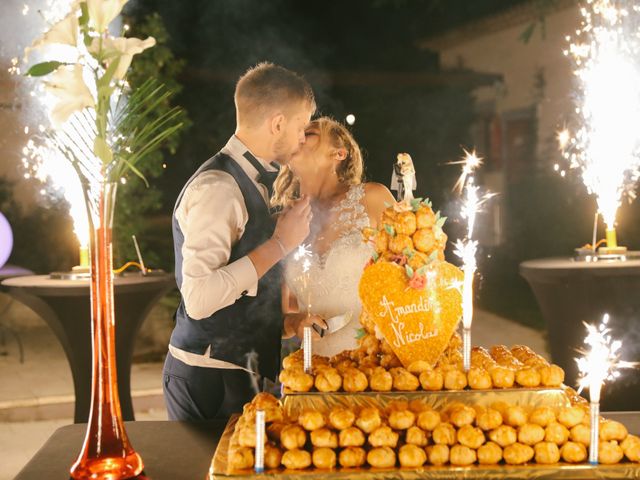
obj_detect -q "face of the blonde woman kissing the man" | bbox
[289,122,335,179]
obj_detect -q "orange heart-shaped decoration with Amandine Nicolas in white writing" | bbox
[359,261,463,367]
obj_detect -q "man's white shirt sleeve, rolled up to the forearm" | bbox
[176,171,258,320]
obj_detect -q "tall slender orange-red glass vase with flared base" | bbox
[70,183,144,480]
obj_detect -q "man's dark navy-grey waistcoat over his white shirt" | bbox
[171,153,282,380]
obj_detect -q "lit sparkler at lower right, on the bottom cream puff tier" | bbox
[576,314,636,464]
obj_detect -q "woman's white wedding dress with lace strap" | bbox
[285,184,373,356]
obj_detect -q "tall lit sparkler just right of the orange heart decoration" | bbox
[452,150,495,371]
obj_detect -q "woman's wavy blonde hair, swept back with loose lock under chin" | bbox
[271,117,364,208]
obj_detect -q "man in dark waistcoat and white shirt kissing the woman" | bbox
[163,63,315,420]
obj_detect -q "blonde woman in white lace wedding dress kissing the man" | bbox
[272,117,394,356]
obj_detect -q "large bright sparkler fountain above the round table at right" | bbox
[558,0,640,253]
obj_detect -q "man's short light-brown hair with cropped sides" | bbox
[234,62,316,126]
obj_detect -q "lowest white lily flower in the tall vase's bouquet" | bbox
[45,63,95,128]
